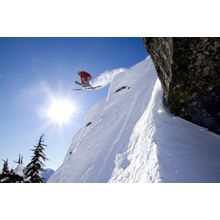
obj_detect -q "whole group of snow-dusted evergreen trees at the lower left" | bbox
[0,134,48,183]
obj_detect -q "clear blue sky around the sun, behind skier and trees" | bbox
[0,38,147,169]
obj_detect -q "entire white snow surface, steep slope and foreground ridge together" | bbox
[48,57,220,183]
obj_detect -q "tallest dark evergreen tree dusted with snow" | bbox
[25,134,47,183]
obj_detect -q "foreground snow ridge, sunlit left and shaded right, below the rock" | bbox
[109,80,220,183]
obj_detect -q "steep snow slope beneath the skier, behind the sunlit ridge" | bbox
[49,56,157,182]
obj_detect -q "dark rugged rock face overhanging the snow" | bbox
[144,37,220,133]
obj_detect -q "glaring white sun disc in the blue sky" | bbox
[46,98,76,125]
